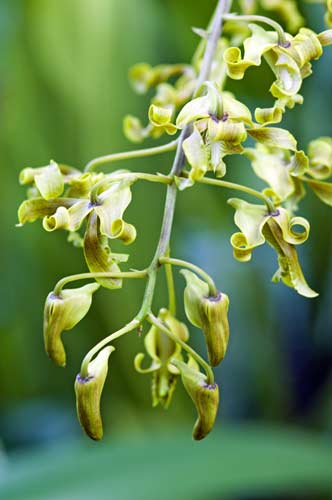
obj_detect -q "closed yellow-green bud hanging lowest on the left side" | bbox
[75,346,115,441]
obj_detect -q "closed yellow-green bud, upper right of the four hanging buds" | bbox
[181,269,229,366]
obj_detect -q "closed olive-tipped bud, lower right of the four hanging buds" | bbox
[172,359,219,440]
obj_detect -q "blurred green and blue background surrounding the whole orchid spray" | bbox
[0,0,332,500]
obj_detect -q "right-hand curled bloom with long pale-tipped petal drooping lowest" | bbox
[228,198,317,297]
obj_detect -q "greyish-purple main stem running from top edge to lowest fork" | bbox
[137,0,231,321]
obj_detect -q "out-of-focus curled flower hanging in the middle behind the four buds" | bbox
[135,309,189,408]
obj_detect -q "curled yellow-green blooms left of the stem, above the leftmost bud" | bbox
[18,165,136,288]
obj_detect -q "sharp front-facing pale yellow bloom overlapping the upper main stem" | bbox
[176,85,297,189]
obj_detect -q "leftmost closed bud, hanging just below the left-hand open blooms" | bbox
[44,283,100,366]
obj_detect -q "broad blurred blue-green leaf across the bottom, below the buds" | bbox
[0,425,332,500]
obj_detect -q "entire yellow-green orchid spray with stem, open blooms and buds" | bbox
[18,0,332,440]
